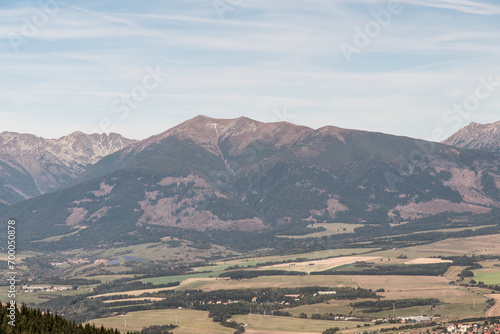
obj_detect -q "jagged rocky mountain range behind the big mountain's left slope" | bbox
[0,132,135,205]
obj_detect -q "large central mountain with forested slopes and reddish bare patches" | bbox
[0,116,500,247]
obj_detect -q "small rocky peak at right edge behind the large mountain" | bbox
[443,121,500,152]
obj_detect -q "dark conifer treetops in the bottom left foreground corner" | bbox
[0,304,120,334]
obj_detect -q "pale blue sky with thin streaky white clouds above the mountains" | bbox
[0,0,500,141]
